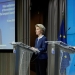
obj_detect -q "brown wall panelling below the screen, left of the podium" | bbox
[0,53,15,75]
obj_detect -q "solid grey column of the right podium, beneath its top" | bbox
[48,44,60,75]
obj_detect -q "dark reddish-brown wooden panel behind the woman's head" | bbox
[30,12,43,46]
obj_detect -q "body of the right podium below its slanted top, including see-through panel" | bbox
[48,44,75,75]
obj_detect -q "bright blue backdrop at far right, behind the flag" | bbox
[66,0,75,75]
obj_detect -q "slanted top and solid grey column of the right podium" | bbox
[46,41,75,75]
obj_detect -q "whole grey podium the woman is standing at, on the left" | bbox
[11,42,39,75]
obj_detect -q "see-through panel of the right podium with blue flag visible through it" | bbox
[59,50,72,75]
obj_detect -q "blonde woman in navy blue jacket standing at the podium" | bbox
[33,24,47,75]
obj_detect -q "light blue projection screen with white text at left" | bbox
[0,0,15,49]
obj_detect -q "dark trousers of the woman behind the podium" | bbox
[36,59,47,75]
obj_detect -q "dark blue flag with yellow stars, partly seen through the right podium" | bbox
[58,19,70,74]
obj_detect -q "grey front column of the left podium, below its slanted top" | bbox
[15,46,33,75]
